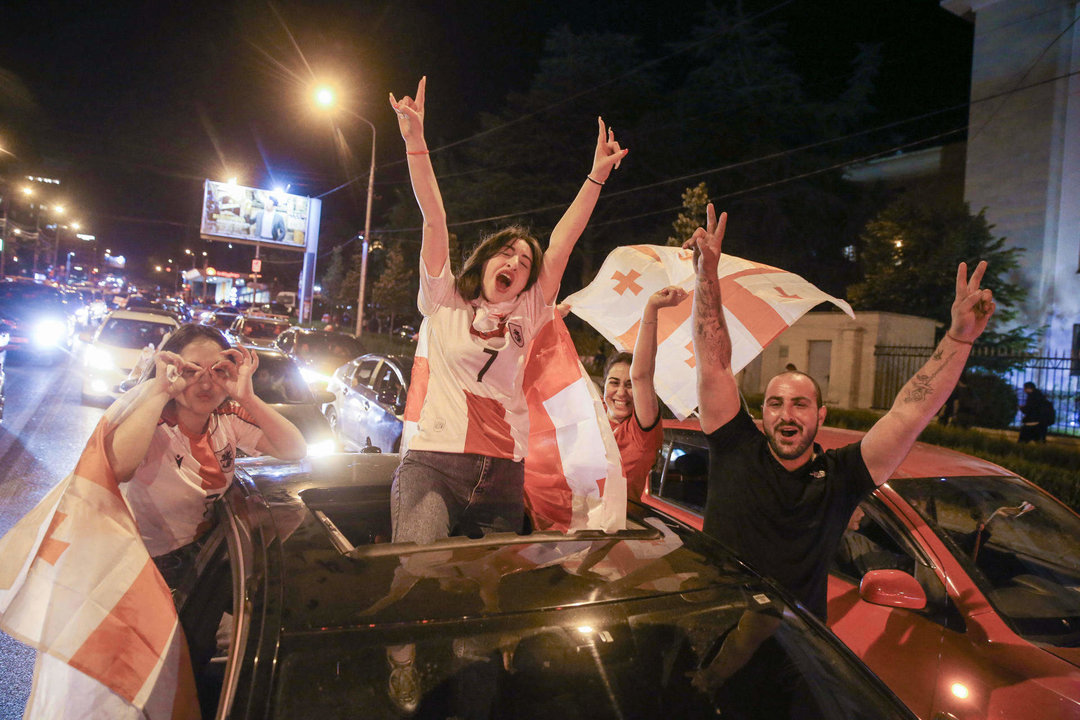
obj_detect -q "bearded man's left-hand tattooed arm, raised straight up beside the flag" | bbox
[683,203,740,433]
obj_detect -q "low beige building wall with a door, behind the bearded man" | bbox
[738,312,937,408]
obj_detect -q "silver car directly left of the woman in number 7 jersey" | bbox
[326,354,413,452]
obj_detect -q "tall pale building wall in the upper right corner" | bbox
[942,0,1080,354]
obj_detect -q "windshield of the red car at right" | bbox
[890,477,1080,647]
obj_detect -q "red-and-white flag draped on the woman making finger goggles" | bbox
[0,389,200,720]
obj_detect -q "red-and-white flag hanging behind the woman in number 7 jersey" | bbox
[524,314,626,532]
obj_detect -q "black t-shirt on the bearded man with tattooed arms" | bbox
[704,410,876,620]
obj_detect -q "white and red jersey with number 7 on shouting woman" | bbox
[402,259,554,461]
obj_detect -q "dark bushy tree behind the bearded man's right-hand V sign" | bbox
[848,191,1034,351]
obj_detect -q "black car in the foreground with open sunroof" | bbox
[174,454,914,720]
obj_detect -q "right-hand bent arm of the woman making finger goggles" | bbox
[212,347,308,460]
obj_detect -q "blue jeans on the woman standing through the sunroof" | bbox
[390,450,525,543]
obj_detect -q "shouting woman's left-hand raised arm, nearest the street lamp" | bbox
[390,76,450,275]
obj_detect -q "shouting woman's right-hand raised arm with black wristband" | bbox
[540,118,630,304]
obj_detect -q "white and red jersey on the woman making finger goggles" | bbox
[120,402,262,557]
